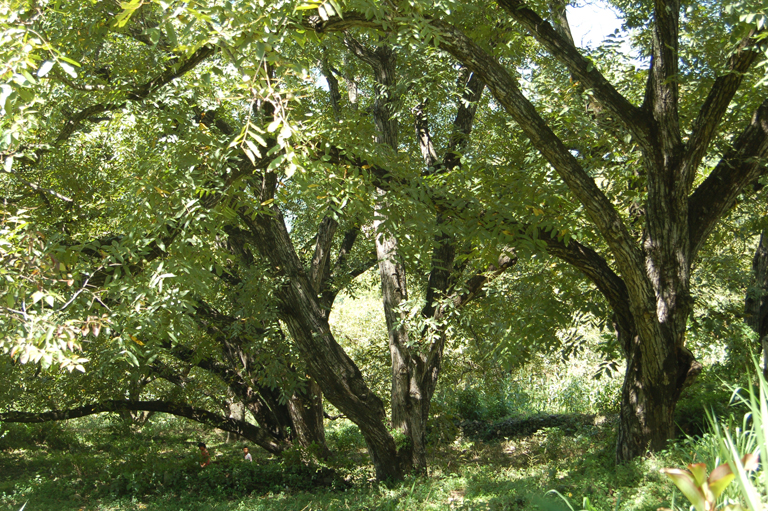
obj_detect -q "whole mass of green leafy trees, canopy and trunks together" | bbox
[0,0,768,479]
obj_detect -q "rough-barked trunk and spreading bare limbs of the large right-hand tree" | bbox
[312,0,768,461]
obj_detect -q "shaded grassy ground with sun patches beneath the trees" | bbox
[0,415,696,511]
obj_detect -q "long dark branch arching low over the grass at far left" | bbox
[0,399,288,454]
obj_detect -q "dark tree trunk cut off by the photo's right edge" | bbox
[744,231,768,379]
